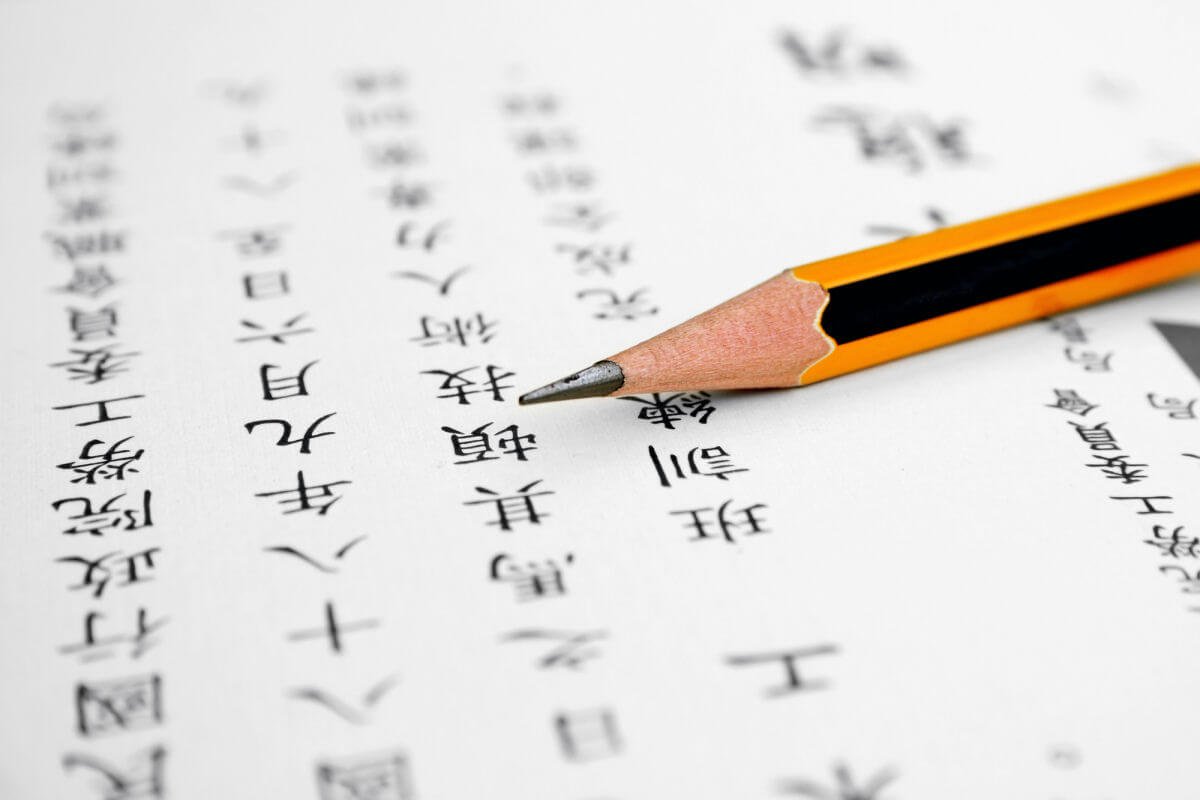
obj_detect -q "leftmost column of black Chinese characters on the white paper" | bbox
[46,103,167,799]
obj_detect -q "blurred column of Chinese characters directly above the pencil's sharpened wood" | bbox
[500,91,659,320]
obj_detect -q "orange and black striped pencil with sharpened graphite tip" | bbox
[520,164,1200,405]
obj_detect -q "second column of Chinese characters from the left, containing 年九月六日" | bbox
[208,73,410,800]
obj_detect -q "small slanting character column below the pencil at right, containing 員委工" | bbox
[1046,389,1200,612]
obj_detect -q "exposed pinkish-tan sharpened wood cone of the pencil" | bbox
[608,272,834,397]
